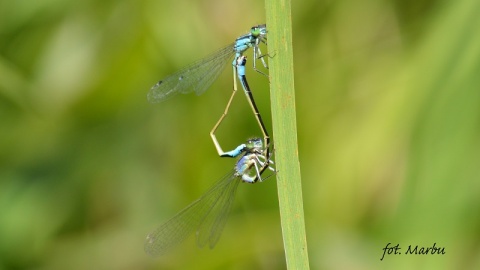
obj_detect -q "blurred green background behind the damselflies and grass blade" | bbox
[0,0,480,270]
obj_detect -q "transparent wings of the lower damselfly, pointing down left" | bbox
[145,170,240,256]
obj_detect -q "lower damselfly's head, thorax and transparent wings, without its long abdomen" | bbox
[145,138,274,256]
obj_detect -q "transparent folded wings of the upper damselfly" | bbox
[147,44,235,103]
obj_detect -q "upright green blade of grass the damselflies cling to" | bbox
[265,0,309,269]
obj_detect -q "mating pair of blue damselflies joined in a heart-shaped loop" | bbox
[145,25,273,256]
